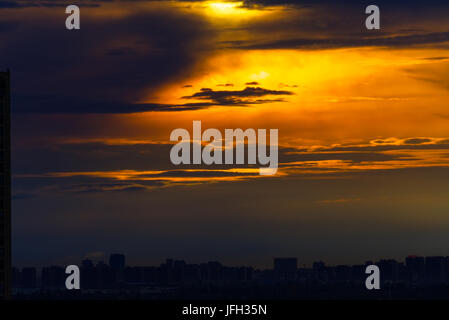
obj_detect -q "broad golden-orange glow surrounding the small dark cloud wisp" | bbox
[148,48,449,140]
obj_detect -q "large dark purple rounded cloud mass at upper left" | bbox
[0,4,214,113]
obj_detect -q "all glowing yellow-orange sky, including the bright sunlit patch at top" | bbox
[12,1,449,181]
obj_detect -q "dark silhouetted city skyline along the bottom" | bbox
[12,254,449,299]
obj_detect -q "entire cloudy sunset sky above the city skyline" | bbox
[0,0,449,267]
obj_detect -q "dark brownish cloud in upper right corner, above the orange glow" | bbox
[222,0,449,50]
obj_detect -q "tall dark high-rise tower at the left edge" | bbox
[0,71,11,299]
